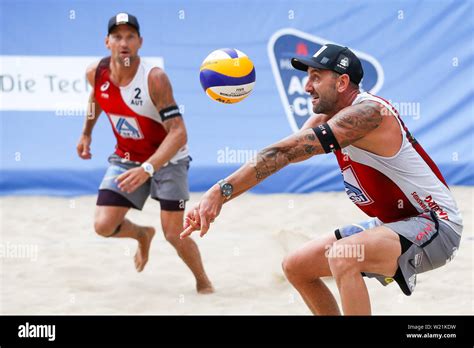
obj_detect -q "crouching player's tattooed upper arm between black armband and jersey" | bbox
[328,102,383,147]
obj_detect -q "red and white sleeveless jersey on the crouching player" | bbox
[335,93,462,231]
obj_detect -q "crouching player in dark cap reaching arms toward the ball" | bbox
[181,44,462,315]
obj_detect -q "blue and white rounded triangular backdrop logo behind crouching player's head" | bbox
[267,28,384,132]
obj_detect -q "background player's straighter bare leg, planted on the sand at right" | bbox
[161,210,214,294]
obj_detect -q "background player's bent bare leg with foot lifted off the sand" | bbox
[94,206,155,272]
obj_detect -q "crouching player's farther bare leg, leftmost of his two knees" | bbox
[283,236,341,315]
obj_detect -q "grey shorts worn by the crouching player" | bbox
[336,211,462,296]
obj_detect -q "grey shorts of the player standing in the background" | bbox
[97,154,191,210]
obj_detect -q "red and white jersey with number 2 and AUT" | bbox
[94,57,188,162]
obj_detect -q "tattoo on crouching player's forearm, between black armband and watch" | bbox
[250,129,323,181]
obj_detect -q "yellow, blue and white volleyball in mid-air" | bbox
[199,48,255,104]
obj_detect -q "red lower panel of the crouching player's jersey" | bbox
[334,150,419,223]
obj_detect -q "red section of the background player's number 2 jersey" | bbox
[94,57,167,162]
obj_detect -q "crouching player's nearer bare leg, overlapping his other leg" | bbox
[329,226,401,315]
